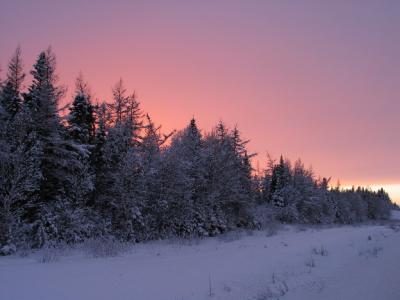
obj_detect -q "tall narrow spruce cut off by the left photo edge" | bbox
[0,47,26,254]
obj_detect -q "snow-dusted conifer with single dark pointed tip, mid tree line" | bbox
[161,119,206,236]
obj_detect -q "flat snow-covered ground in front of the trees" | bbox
[0,212,400,300]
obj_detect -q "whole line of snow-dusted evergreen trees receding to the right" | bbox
[0,48,392,254]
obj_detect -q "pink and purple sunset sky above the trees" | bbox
[0,0,400,202]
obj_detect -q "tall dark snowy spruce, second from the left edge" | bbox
[20,49,90,247]
